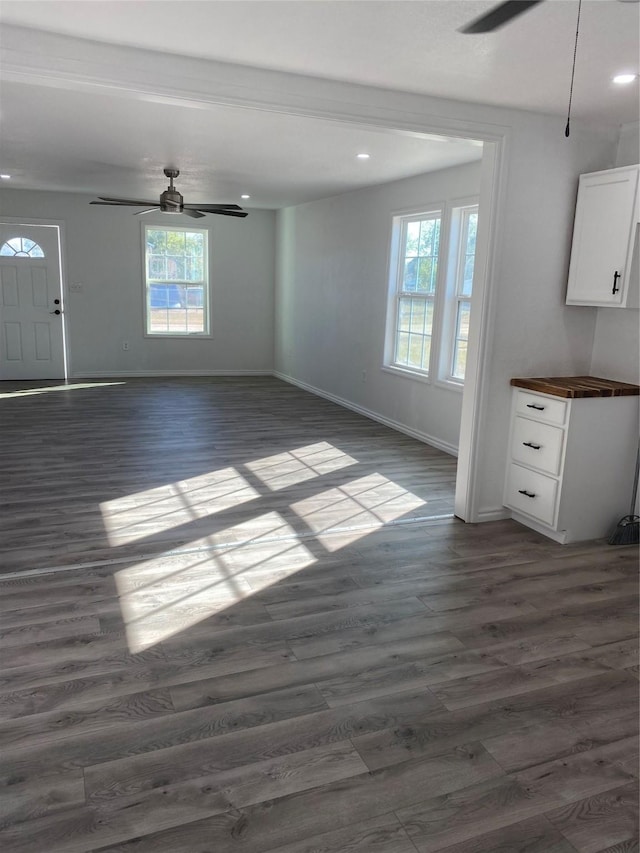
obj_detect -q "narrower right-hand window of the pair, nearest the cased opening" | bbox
[444,205,478,382]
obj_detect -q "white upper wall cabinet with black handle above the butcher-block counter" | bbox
[567,166,640,308]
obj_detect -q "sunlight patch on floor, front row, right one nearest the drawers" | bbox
[291,474,427,551]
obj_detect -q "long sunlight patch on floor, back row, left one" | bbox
[100,468,260,545]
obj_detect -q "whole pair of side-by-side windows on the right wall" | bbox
[385,203,478,388]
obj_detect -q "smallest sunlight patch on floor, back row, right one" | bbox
[245,441,358,491]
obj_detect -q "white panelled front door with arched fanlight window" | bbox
[0,223,65,379]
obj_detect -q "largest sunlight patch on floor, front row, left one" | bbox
[114,513,316,654]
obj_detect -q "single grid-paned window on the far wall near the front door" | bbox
[144,226,209,336]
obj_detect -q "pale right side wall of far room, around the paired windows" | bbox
[275,161,480,450]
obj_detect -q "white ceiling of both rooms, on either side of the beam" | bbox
[0,0,640,207]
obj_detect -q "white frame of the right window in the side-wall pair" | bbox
[437,197,478,391]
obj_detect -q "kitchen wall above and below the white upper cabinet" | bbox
[585,122,640,385]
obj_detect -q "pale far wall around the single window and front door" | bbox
[0,190,275,377]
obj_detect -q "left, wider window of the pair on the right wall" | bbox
[390,210,441,375]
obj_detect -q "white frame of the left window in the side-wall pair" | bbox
[383,204,447,382]
